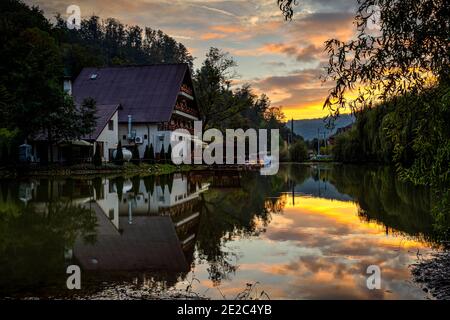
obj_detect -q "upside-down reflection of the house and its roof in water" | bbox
[73,174,208,272]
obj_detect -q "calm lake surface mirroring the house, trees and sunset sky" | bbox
[0,164,435,299]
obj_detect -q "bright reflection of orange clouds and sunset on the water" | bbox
[180,194,427,299]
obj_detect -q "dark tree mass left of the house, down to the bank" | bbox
[0,7,95,160]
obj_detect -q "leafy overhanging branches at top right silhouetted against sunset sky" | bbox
[324,0,450,116]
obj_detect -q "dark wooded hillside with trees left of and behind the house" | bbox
[0,0,193,140]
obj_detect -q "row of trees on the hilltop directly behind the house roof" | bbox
[53,11,194,76]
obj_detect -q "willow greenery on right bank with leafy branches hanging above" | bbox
[312,0,450,239]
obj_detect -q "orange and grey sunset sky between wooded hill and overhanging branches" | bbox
[25,0,356,119]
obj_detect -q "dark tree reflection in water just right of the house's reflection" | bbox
[197,173,286,285]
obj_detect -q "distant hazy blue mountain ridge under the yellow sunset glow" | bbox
[287,114,355,140]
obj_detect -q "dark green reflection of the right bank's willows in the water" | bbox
[330,165,434,240]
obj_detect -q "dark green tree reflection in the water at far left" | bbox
[0,184,96,295]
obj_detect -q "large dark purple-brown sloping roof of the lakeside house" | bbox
[72,63,189,122]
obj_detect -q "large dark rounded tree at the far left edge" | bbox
[0,28,64,137]
